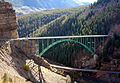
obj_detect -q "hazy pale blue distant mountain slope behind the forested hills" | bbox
[7,0,90,15]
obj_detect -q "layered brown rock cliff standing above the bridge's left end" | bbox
[0,2,18,38]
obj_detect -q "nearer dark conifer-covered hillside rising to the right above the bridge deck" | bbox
[31,0,120,36]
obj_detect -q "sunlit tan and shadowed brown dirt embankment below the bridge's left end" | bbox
[0,41,70,83]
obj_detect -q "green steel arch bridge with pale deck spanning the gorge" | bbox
[36,35,109,56]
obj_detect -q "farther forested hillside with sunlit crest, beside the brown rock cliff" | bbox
[17,6,87,37]
